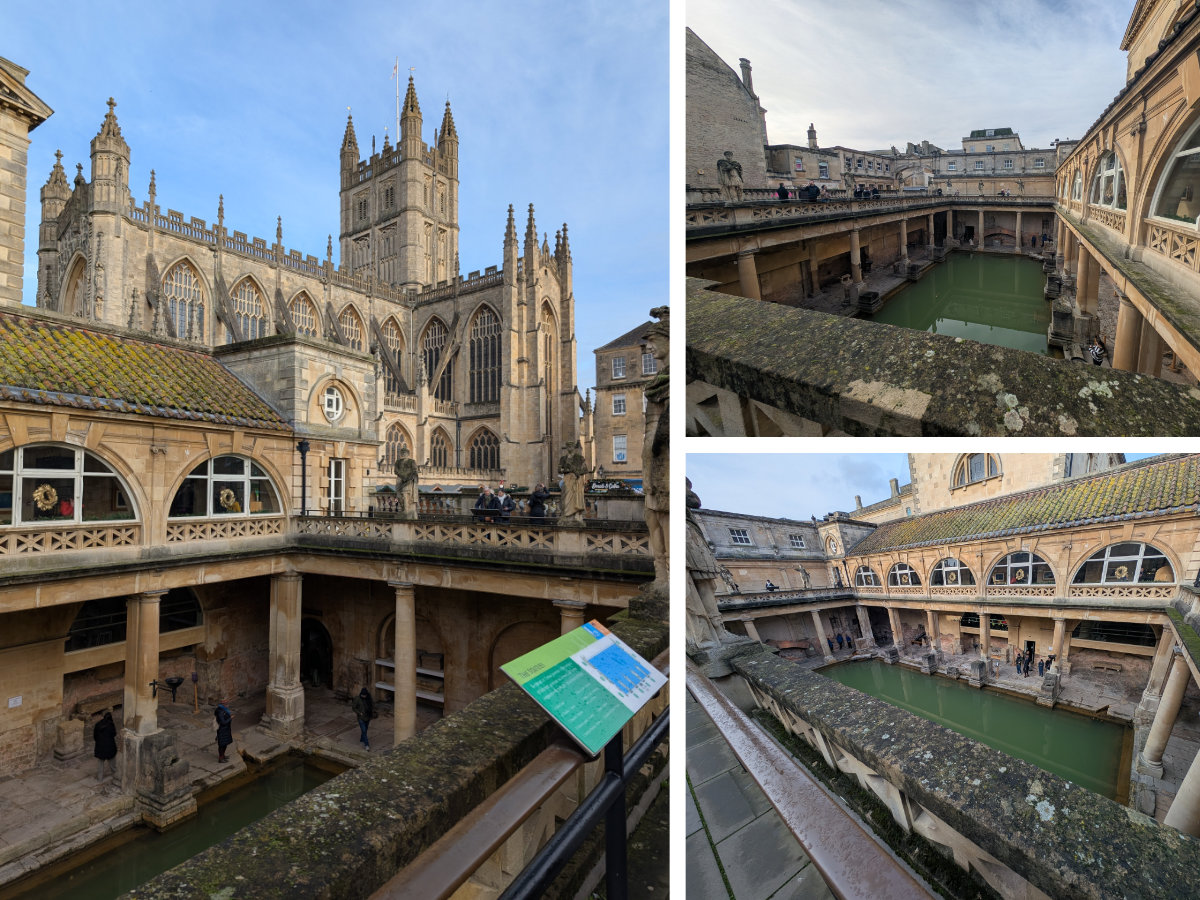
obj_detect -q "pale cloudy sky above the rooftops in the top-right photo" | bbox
[685,0,1134,151]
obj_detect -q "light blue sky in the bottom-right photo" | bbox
[688,451,1153,520]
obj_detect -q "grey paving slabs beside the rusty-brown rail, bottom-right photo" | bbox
[685,694,834,900]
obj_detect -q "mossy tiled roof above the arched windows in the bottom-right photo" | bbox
[847,456,1200,556]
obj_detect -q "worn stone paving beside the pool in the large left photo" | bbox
[0,683,437,893]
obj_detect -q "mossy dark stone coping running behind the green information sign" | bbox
[126,618,667,900]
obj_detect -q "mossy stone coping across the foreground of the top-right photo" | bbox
[686,278,1200,437]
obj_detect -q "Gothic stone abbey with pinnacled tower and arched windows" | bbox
[37,78,580,494]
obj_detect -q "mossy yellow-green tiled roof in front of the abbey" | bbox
[0,312,289,431]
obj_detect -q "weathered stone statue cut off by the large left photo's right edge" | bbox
[642,306,671,590]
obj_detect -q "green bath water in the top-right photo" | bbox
[864,252,1050,355]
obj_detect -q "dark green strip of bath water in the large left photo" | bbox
[9,757,334,900]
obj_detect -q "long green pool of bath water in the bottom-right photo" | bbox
[821,660,1126,799]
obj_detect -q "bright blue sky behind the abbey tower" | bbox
[7,0,668,391]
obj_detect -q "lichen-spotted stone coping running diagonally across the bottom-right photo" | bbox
[732,650,1200,900]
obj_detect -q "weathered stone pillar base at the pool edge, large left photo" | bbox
[121,731,196,832]
